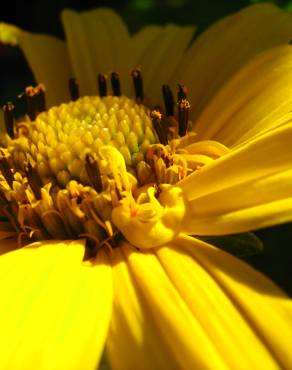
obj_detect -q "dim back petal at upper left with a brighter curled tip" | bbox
[0,23,71,107]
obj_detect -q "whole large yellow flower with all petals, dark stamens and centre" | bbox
[0,4,292,370]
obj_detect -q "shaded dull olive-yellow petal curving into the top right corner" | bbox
[181,4,292,121]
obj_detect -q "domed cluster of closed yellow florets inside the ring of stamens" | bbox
[8,96,157,186]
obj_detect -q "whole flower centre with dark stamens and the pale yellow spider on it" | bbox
[0,71,227,253]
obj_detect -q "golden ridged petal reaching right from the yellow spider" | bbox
[179,124,292,235]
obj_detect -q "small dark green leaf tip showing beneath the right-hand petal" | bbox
[196,233,263,257]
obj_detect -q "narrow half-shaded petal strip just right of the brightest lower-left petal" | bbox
[106,243,178,370]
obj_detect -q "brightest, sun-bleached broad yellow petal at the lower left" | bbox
[0,241,112,369]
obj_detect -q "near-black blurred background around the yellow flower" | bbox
[0,0,292,295]
